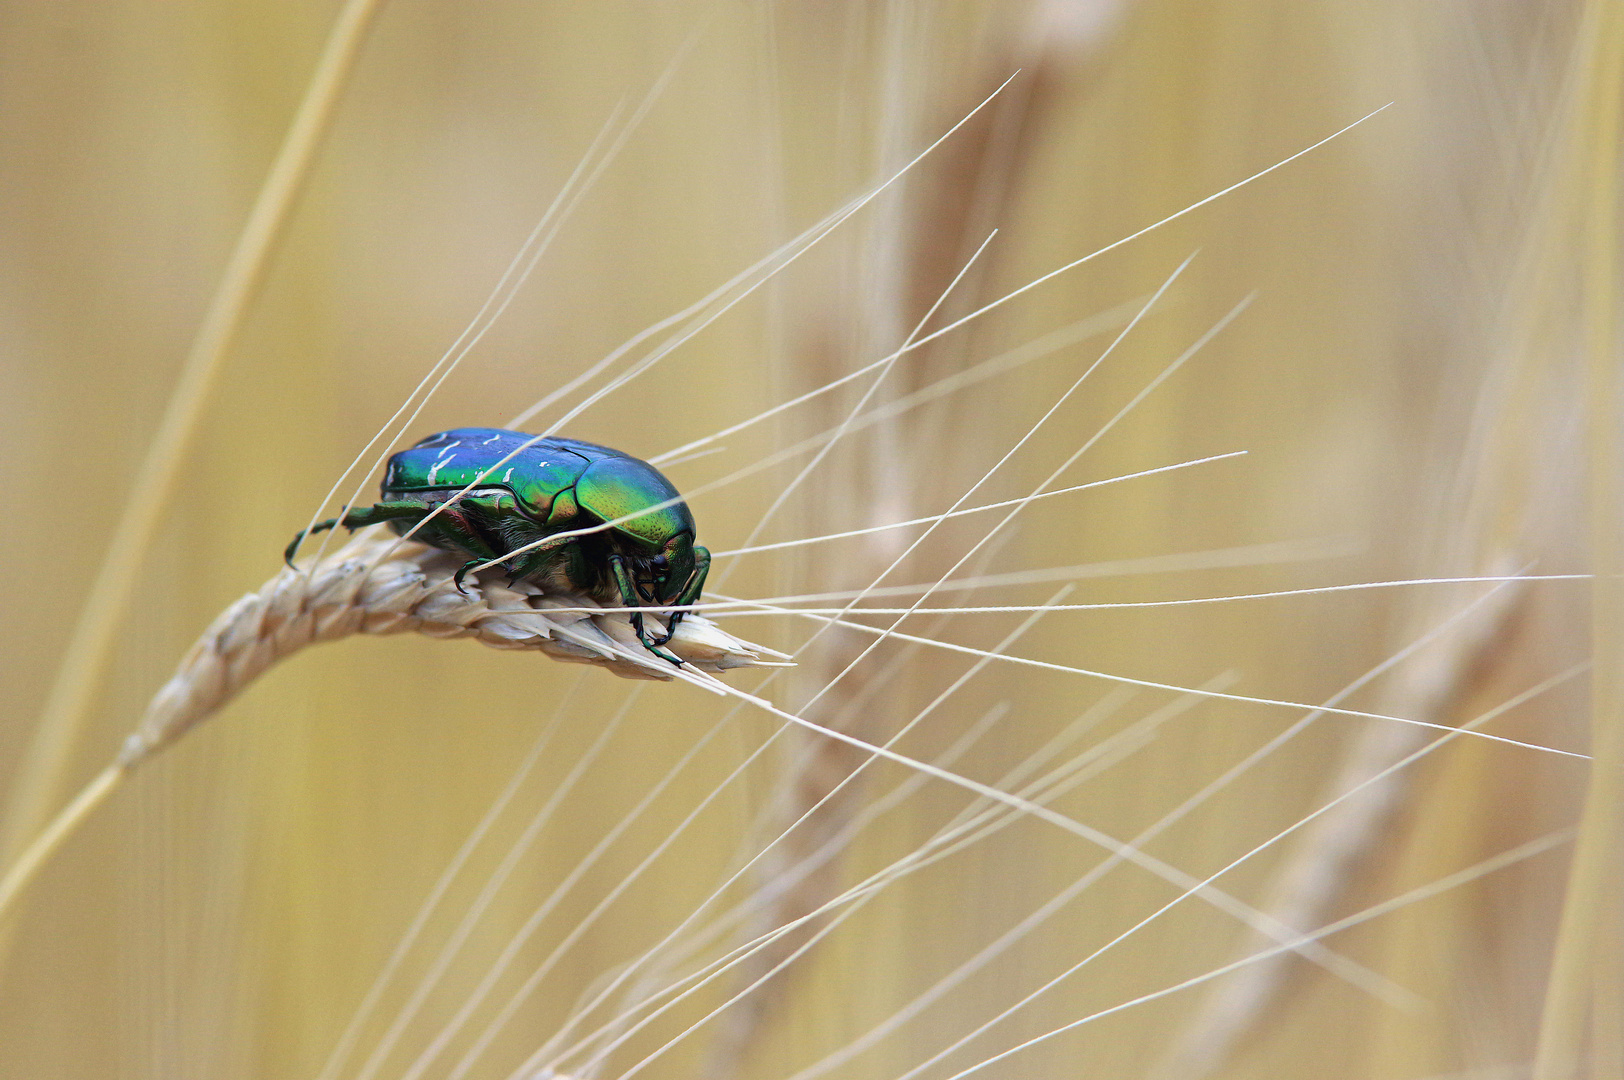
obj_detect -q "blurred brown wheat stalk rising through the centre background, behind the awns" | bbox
[706,3,1098,1078]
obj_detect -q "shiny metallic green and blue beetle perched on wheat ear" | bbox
[286,427,710,664]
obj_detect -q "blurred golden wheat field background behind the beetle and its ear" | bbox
[0,0,1624,1080]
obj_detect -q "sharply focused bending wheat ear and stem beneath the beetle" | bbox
[0,526,781,919]
